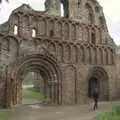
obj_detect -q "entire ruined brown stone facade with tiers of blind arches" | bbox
[0,0,118,106]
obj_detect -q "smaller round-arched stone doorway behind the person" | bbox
[88,67,109,100]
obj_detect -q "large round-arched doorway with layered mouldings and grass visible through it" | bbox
[7,54,62,106]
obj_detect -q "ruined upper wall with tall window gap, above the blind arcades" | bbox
[45,0,107,27]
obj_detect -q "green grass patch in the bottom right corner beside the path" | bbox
[96,112,120,120]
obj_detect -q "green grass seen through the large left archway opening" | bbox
[23,87,44,100]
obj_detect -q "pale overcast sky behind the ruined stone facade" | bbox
[0,0,120,45]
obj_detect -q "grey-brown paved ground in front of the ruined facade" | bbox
[7,102,120,120]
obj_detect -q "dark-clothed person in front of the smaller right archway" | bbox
[93,87,99,110]
